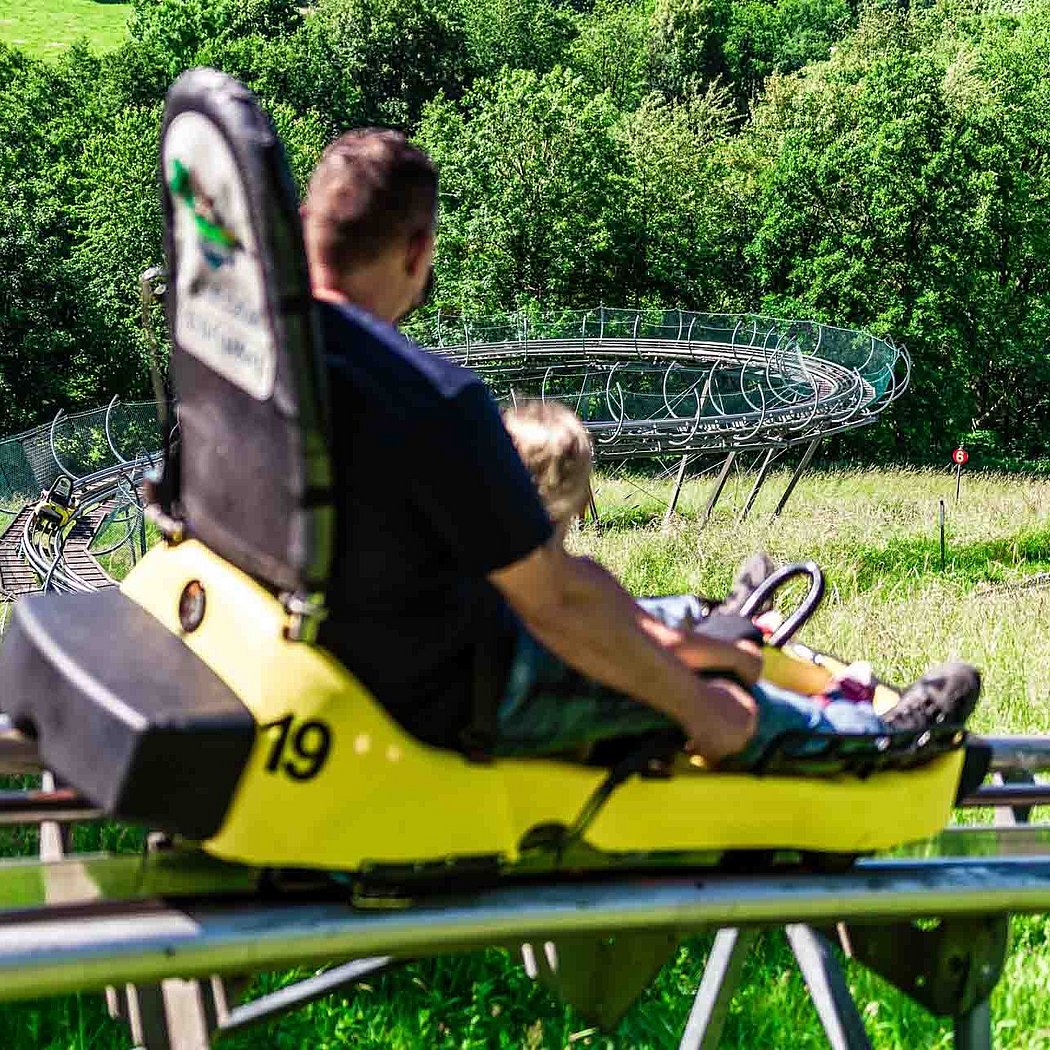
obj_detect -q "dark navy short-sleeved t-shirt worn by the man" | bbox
[318,302,551,747]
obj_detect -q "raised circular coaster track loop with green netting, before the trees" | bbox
[416,308,910,459]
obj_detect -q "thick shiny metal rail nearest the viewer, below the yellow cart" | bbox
[0,857,1050,1000]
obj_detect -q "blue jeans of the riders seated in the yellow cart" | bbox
[495,594,886,767]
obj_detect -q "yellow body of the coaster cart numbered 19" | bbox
[123,541,963,870]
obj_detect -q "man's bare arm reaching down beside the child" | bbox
[489,543,761,759]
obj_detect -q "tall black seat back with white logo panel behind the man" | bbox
[160,69,333,594]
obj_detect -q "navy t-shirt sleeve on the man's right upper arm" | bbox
[413,382,553,575]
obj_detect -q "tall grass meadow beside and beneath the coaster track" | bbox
[0,470,1050,1050]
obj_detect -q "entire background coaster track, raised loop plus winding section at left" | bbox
[0,307,910,600]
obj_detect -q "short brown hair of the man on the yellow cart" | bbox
[302,128,438,273]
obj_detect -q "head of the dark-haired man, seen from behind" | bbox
[302,128,438,322]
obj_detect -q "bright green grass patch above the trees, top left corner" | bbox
[0,0,131,58]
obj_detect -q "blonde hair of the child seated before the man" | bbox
[503,401,593,525]
